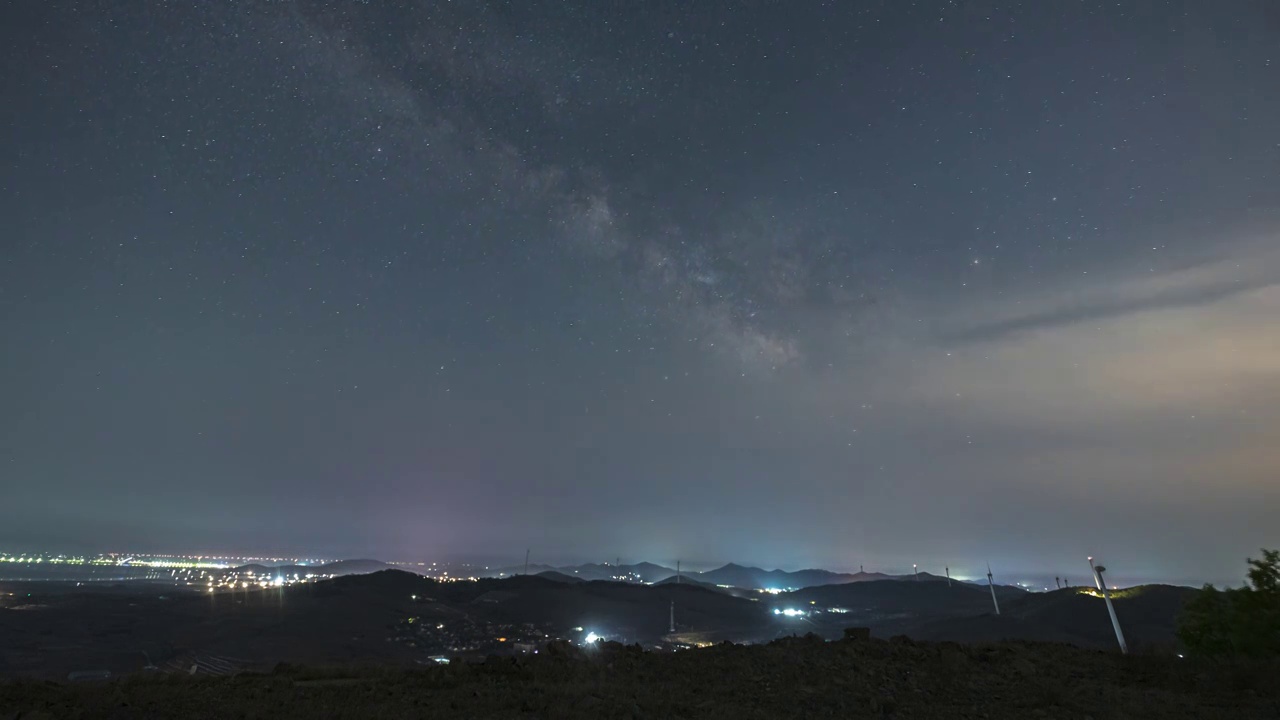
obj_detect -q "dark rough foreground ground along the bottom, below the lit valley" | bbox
[0,638,1280,720]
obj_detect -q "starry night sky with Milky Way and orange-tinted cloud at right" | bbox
[0,0,1280,582]
